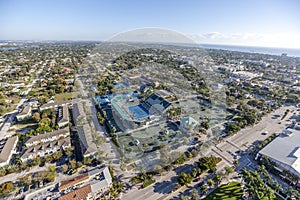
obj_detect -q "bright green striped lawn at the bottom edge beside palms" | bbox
[205,182,243,200]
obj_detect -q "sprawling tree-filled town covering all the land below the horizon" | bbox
[0,39,300,200]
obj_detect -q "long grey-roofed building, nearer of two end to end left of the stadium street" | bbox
[77,124,97,157]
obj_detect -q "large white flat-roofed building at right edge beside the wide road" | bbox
[257,129,300,177]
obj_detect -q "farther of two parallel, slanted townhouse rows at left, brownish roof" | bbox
[25,127,70,147]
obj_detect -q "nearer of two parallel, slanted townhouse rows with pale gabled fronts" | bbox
[21,137,71,162]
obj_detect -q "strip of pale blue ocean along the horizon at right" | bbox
[200,44,300,57]
